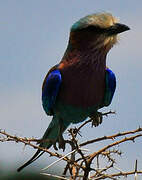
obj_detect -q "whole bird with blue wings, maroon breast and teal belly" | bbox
[17,12,130,172]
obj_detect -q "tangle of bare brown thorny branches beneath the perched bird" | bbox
[0,111,142,180]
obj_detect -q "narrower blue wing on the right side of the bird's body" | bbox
[104,68,116,106]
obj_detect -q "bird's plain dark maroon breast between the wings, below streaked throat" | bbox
[59,64,105,108]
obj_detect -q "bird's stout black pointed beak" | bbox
[108,23,130,35]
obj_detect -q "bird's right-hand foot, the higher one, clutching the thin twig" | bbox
[90,112,103,127]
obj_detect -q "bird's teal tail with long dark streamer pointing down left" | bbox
[17,116,69,172]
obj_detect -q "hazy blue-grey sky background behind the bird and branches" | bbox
[0,0,142,179]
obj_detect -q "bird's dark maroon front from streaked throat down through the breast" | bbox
[59,44,106,108]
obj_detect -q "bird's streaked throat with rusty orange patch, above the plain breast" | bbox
[59,42,107,72]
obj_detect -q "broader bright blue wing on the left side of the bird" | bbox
[42,67,62,115]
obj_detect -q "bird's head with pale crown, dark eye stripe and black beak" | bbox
[69,13,130,51]
